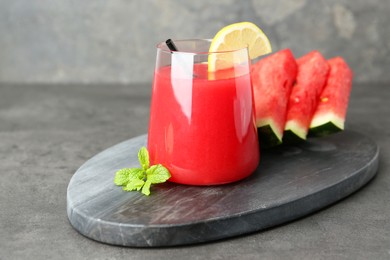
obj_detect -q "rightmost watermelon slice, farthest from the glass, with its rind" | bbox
[309,57,352,136]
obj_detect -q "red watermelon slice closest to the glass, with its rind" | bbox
[252,49,297,148]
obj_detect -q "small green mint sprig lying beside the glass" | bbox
[114,146,171,196]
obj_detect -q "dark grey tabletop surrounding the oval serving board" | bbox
[0,83,390,259]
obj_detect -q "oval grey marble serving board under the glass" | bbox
[67,131,379,247]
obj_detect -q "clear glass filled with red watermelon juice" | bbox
[148,39,260,185]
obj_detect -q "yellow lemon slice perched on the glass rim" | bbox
[208,22,272,71]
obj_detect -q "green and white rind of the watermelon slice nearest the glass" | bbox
[256,118,283,148]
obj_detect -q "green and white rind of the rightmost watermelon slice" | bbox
[309,112,345,137]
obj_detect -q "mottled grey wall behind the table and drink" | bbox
[0,0,390,83]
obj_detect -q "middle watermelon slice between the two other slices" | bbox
[283,51,329,143]
